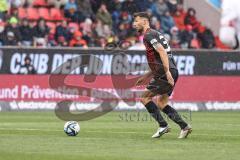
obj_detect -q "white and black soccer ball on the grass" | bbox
[64,121,80,136]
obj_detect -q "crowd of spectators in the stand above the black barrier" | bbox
[0,0,229,49]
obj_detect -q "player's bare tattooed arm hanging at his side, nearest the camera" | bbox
[152,42,174,86]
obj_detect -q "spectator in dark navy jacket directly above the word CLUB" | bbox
[19,19,33,46]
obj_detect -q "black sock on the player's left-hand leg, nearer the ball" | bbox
[145,101,168,127]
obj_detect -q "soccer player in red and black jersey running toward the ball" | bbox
[133,12,192,138]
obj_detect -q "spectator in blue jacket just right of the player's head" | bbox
[161,11,175,34]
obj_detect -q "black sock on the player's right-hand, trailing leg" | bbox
[162,105,187,129]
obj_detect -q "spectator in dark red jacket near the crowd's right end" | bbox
[184,8,199,31]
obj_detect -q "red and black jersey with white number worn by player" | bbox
[143,28,177,75]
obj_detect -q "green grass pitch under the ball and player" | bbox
[0,111,240,160]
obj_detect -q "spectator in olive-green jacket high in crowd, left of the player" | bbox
[96,4,112,28]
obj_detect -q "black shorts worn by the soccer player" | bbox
[147,69,178,96]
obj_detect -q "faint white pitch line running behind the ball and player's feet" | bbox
[0,128,240,137]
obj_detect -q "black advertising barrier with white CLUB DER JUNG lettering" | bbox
[0,48,240,75]
